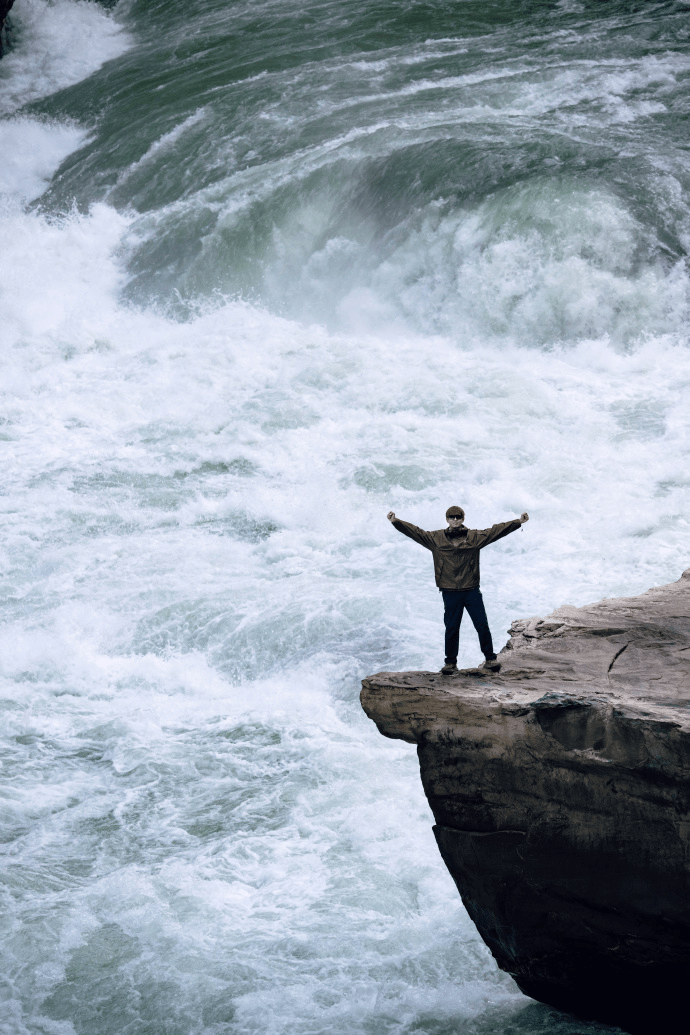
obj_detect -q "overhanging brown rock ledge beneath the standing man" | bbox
[361,569,690,1033]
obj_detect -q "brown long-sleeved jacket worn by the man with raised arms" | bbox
[391,518,520,589]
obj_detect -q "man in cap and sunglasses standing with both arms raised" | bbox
[387,507,530,676]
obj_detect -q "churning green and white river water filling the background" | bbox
[0,0,690,1035]
